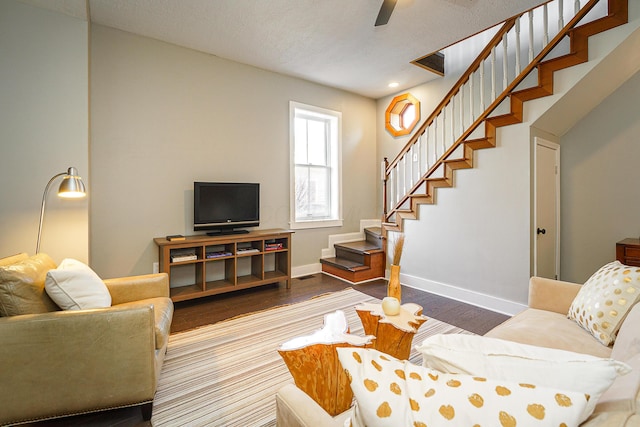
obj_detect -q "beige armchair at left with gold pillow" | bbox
[0,254,173,425]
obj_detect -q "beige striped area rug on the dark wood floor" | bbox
[152,288,466,427]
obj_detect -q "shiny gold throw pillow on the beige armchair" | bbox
[0,253,58,316]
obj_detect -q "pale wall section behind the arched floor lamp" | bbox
[0,0,91,262]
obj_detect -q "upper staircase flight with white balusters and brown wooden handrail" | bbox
[382,0,628,231]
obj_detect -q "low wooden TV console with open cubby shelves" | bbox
[153,229,293,301]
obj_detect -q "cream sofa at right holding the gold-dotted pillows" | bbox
[276,277,640,427]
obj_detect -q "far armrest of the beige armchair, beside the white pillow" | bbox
[104,273,169,305]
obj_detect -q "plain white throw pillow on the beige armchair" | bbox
[44,258,111,310]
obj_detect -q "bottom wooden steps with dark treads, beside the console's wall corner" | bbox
[320,227,386,283]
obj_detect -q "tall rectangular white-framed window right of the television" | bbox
[289,102,342,229]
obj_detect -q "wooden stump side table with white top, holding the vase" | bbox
[356,303,427,360]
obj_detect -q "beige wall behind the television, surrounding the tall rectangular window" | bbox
[91,25,378,277]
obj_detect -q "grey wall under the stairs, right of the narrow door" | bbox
[560,72,640,283]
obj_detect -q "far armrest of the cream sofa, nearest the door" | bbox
[529,276,582,314]
